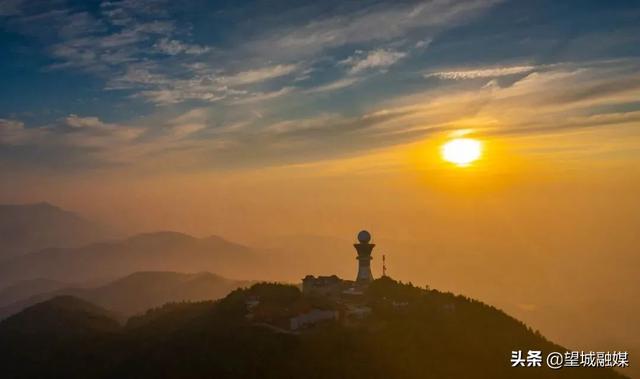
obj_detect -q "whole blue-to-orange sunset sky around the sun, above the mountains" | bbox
[0,0,640,372]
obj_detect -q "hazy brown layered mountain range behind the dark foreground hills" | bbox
[0,203,276,319]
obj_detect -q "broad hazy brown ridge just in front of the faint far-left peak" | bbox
[0,232,270,287]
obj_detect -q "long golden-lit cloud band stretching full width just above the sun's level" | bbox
[5,60,640,173]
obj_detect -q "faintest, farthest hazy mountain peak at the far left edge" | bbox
[0,203,110,260]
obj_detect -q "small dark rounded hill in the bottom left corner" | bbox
[0,296,122,378]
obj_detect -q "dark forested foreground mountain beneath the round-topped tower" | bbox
[0,278,624,379]
